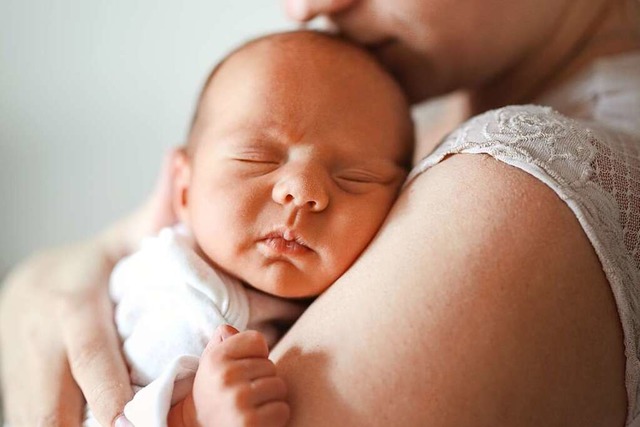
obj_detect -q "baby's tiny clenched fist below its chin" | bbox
[168,325,289,427]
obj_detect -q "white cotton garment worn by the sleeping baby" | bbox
[85,227,249,427]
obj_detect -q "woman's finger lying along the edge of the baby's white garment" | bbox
[60,288,133,426]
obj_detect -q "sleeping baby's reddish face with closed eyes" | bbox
[178,34,412,297]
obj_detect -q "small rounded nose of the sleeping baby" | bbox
[272,169,329,212]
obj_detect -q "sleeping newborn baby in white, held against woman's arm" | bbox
[95,31,413,427]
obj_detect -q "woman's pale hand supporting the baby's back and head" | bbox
[0,151,176,426]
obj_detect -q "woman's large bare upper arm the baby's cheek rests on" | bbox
[272,155,626,427]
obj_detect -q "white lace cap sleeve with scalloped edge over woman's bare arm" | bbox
[405,105,640,423]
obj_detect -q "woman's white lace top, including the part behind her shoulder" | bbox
[409,52,640,427]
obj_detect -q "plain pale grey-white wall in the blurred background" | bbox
[0,0,292,278]
